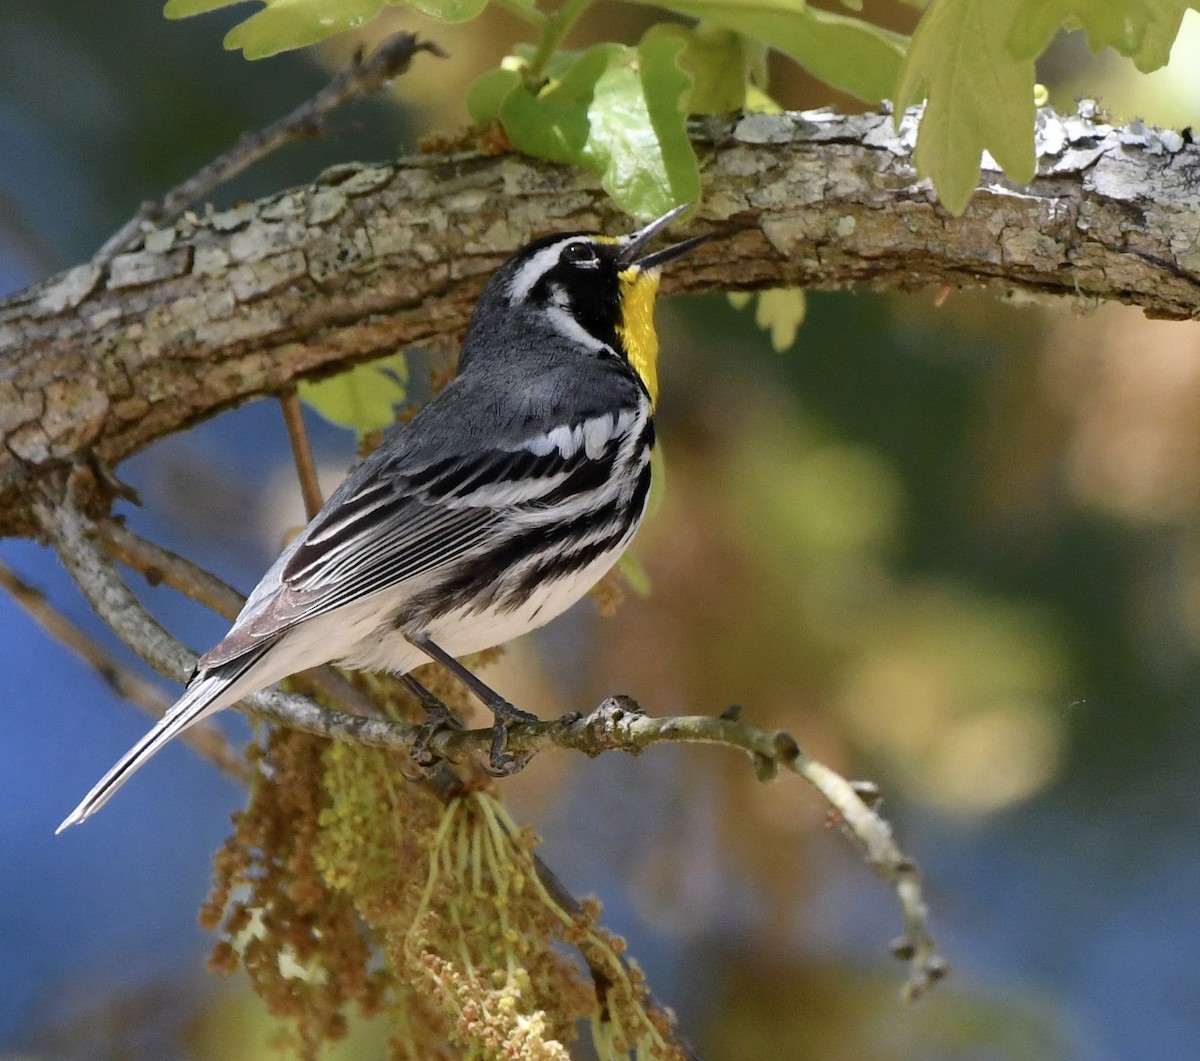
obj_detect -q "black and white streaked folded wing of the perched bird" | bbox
[200,400,649,669]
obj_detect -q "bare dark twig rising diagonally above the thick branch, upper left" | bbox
[92,34,445,264]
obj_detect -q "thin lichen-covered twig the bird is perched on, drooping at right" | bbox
[34,489,947,999]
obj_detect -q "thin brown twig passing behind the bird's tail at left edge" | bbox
[0,552,251,785]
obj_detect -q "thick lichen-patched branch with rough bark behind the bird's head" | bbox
[0,105,1200,535]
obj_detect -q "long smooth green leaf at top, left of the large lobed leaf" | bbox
[637,0,906,103]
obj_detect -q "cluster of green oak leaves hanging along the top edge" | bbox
[166,0,1198,218]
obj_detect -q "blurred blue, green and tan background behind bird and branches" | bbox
[0,0,1200,1061]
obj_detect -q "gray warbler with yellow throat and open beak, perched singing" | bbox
[56,204,720,833]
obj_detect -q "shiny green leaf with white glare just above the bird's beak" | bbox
[583,38,700,217]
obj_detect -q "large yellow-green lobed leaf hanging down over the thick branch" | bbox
[896,0,1037,215]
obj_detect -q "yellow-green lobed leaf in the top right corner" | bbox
[1007,0,1200,73]
